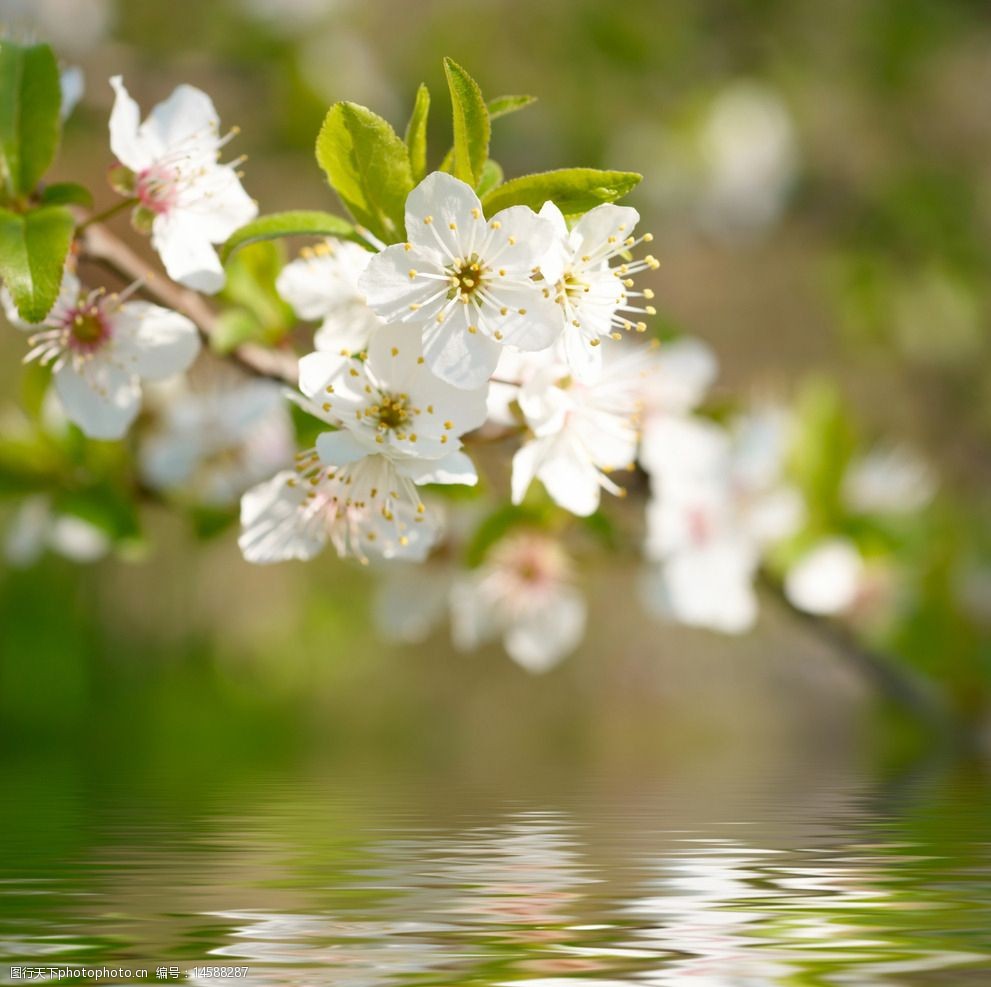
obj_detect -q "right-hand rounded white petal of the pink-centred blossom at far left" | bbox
[111,302,200,380]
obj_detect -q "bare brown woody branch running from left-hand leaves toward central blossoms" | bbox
[79,223,297,386]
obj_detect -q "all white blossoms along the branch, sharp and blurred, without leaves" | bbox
[3,65,948,671]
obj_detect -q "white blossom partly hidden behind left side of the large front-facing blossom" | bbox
[275,240,382,353]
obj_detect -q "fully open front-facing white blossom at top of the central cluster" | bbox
[359,172,560,389]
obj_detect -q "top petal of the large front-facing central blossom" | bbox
[406,171,485,261]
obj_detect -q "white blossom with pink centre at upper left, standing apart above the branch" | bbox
[110,76,258,293]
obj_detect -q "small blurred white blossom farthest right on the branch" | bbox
[843,446,936,514]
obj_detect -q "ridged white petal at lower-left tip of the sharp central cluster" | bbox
[238,471,327,565]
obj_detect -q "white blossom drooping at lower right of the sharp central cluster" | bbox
[512,346,650,517]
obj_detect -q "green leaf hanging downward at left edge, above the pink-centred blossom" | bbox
[0,206,76,322]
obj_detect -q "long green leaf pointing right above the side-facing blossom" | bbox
[482,168,643,216]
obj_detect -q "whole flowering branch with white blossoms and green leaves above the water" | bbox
[0,41,984,740]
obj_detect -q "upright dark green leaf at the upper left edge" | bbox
[0,41,62,201]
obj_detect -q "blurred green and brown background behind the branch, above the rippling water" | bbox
[0,0,991,789]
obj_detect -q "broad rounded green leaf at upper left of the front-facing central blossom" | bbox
[317,103,413,243]
